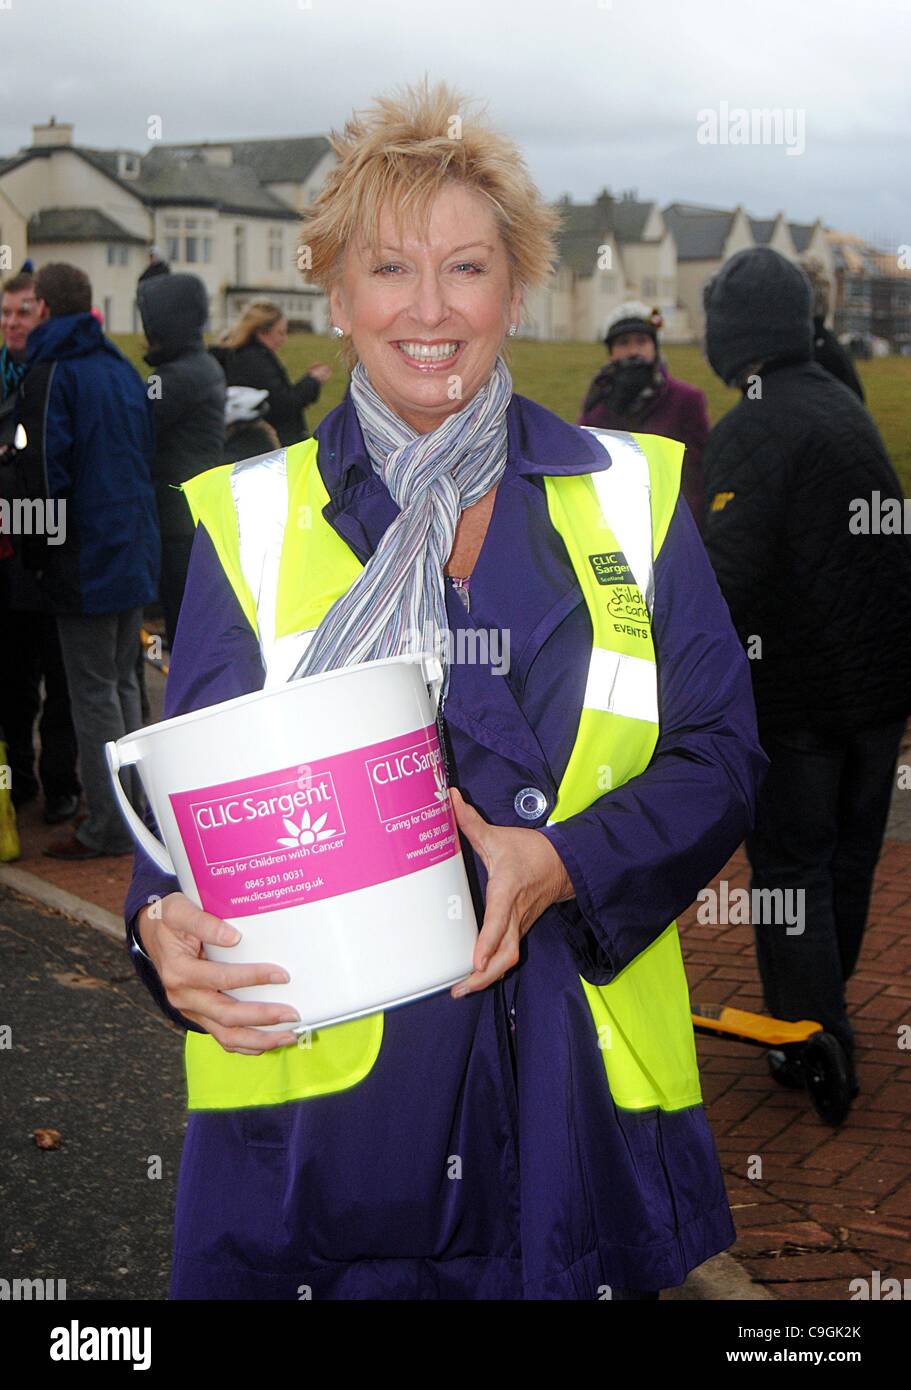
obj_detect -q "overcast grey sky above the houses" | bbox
[0,0,911,246]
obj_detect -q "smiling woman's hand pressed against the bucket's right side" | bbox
[452,787,576,999]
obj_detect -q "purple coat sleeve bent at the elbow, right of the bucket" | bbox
[541,498,766,984]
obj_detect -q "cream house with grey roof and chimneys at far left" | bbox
[0,118,335,332]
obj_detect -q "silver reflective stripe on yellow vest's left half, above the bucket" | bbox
[231,449,316,689]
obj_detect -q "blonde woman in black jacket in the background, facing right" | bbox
[211,299,332,445]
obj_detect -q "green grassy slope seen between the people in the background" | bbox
[115,334,911,496]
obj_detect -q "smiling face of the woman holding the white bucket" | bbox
[330,183,522,434]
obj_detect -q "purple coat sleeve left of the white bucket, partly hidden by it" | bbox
[124,525,263,1033]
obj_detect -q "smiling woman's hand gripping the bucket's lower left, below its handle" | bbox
[138,892,299,1056]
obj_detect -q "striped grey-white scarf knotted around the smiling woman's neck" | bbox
[291,357,512,698]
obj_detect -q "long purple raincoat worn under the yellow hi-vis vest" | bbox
[125,395,766,1300]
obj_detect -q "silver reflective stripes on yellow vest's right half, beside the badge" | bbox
[583,425,658,724]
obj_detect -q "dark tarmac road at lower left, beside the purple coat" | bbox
[0,888,185,1300]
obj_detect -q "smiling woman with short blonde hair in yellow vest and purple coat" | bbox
[125,83,764,1300]
